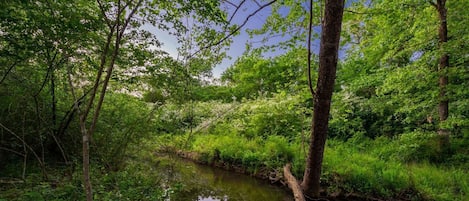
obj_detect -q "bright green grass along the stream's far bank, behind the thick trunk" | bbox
[163,130,469,201]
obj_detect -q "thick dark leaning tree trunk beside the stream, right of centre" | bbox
[301,0,344,197]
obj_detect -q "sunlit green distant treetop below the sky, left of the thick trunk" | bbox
[222,48,307,98]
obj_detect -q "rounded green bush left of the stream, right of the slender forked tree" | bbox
[92,93,154,169]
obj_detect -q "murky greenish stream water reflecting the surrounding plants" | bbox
[154,156,293,201]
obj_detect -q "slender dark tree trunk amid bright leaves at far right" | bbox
[435,0,450,153]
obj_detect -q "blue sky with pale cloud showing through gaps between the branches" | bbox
[150,0,319,78]
